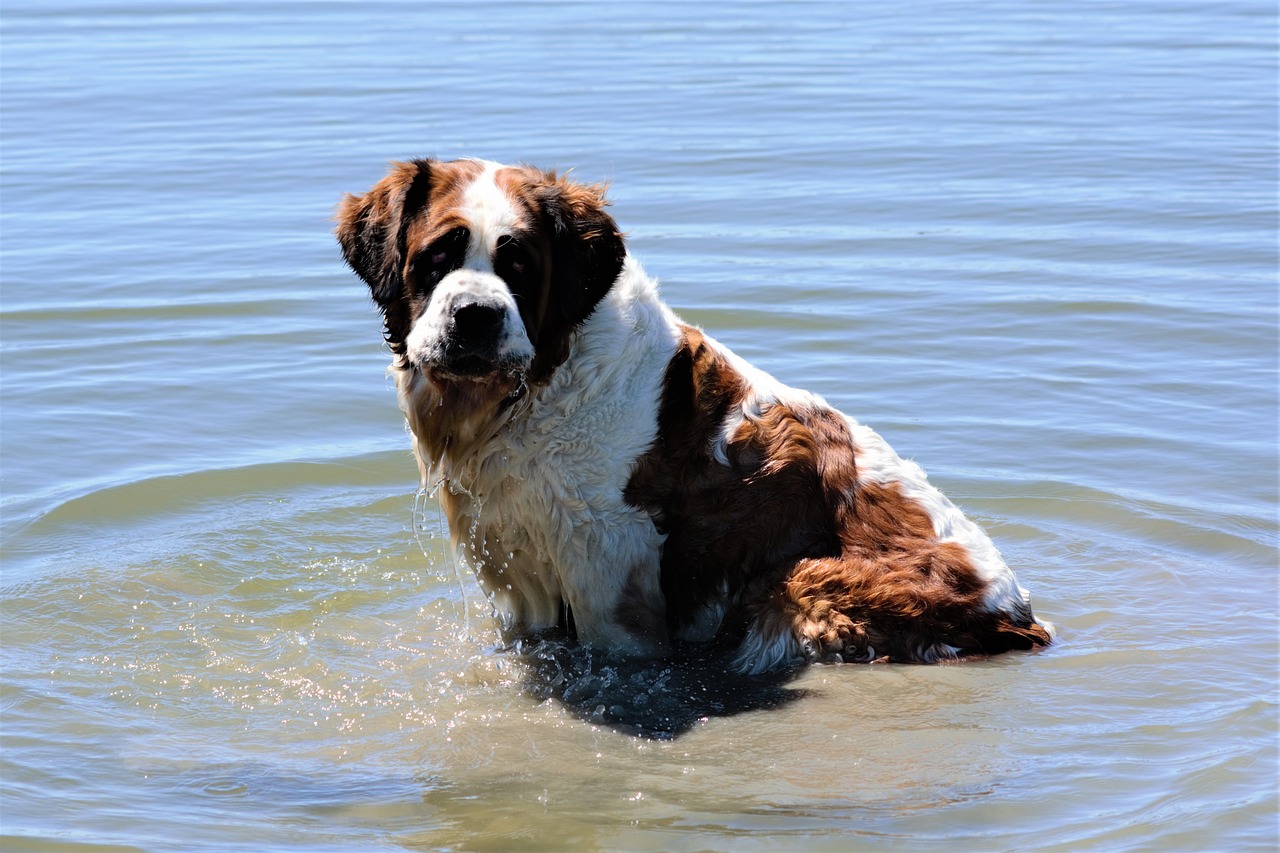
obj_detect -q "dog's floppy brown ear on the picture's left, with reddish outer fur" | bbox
[335,160,431,307]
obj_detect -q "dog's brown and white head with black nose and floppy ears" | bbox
[337,160,626,393]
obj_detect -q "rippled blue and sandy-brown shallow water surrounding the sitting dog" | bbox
[0,0,1277,850]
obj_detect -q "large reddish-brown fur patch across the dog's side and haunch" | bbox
[626,322,1048,661]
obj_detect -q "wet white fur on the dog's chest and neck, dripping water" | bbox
[424,260,678,653]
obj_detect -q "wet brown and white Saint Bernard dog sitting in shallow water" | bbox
[337,160,1051,674]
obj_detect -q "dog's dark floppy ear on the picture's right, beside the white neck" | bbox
[540,174,627,333]
